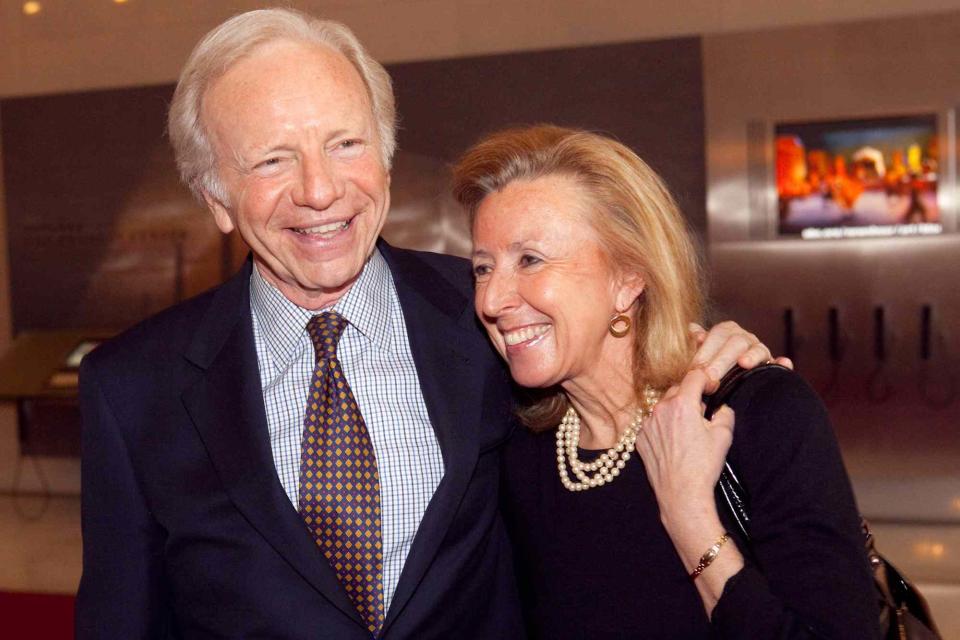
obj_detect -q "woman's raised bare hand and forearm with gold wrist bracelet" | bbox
[637,369,743,616]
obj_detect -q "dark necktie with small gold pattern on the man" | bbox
[298,311,384,635]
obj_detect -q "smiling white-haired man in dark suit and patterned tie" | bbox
[77,10,780,639]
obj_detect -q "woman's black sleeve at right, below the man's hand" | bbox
[712,370,880,640]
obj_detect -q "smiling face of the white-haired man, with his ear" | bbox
[202,42,390,309]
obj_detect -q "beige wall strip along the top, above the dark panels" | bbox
[0,0,960,96]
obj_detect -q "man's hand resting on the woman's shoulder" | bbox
[690,320,793,393]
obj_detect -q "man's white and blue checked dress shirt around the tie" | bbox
[250,251,443,611]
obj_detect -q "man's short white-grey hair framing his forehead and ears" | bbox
[167,9,397,202]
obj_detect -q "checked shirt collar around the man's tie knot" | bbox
[250,249,395,366]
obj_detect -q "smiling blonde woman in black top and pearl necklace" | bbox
[454,126,879,640]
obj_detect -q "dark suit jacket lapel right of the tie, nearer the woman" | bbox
[380,243,487,631]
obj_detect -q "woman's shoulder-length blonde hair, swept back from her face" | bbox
[453,125,704,430]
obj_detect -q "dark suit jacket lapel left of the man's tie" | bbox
[182,263,363,626]
